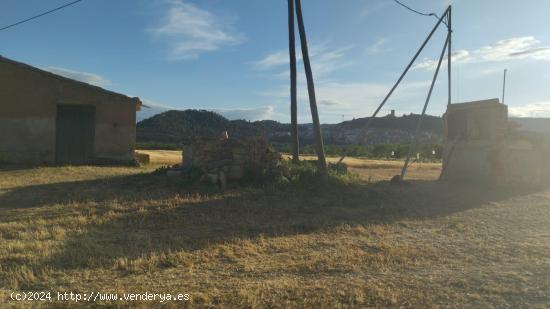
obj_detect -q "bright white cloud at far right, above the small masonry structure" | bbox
[413,36,550,70]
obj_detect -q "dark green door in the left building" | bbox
[55,105,95,164]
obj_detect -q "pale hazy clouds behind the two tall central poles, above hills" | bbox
[251,39,444,121]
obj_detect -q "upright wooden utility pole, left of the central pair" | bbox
[288,0,300,163]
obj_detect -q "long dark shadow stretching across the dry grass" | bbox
[0,170,548,269]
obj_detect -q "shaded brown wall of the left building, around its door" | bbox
[0,60,139,163]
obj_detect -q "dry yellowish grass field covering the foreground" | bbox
[0,151,550,308]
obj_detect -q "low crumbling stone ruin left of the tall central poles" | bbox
[176,135,283,187]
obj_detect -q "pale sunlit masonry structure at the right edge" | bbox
[443,100,550,185]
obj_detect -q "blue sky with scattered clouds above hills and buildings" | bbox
[0,0,550,123]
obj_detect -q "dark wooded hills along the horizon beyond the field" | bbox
[137,110,448,145]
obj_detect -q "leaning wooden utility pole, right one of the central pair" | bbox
[296,0,328,182]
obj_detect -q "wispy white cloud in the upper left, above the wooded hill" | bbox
[150,0,244,60]
